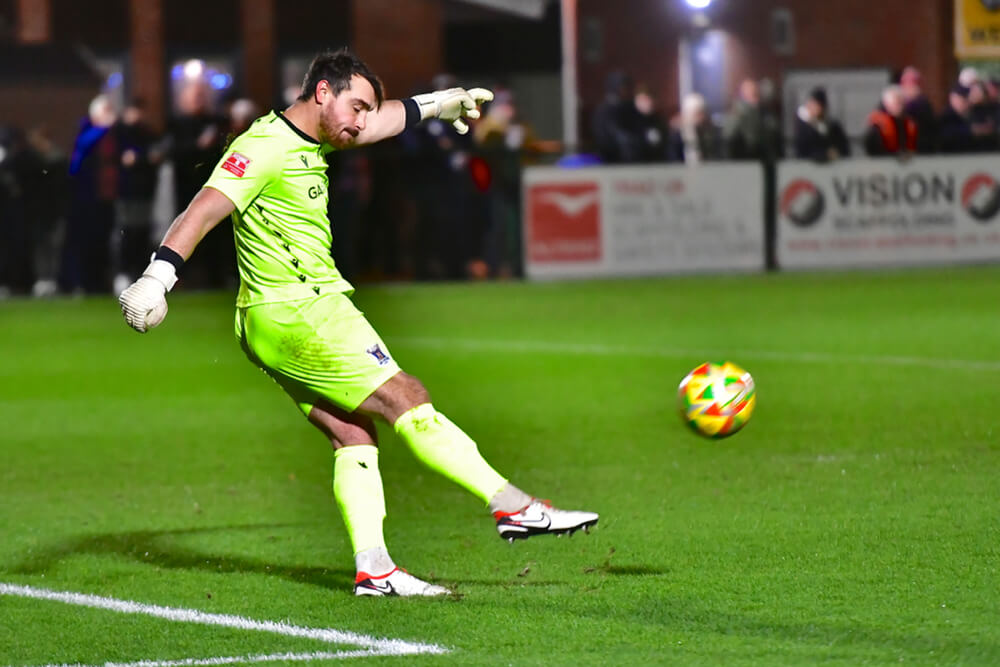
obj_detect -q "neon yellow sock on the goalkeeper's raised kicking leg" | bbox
[393,403,507,504]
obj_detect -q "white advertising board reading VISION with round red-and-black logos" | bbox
[776,155,1000,268]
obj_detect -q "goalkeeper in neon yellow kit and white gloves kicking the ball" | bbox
[119,49,598,596]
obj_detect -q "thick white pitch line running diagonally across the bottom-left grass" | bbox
[0,582,448,664]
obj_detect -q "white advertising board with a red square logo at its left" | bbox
[522,164,764,278]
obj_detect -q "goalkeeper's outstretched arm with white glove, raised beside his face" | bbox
[356,88,493,145]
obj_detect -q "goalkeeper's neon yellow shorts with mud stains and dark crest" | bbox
[236,294,399,415]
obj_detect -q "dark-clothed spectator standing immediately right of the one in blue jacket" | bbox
[111,99,162,294]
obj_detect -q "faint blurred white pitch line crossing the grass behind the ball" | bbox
[390,338,1000,371]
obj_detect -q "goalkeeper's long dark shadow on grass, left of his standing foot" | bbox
[2,524,354,591]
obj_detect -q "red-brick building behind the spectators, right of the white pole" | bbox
[574,0,957,144]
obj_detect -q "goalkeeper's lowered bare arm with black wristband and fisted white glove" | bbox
[118,187,236,333]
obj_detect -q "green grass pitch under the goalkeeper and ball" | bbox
[0,266,1000,666]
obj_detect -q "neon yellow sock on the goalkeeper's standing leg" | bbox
[333,445,385,554]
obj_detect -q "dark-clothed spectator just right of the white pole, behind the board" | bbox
[592,71,643,164]
